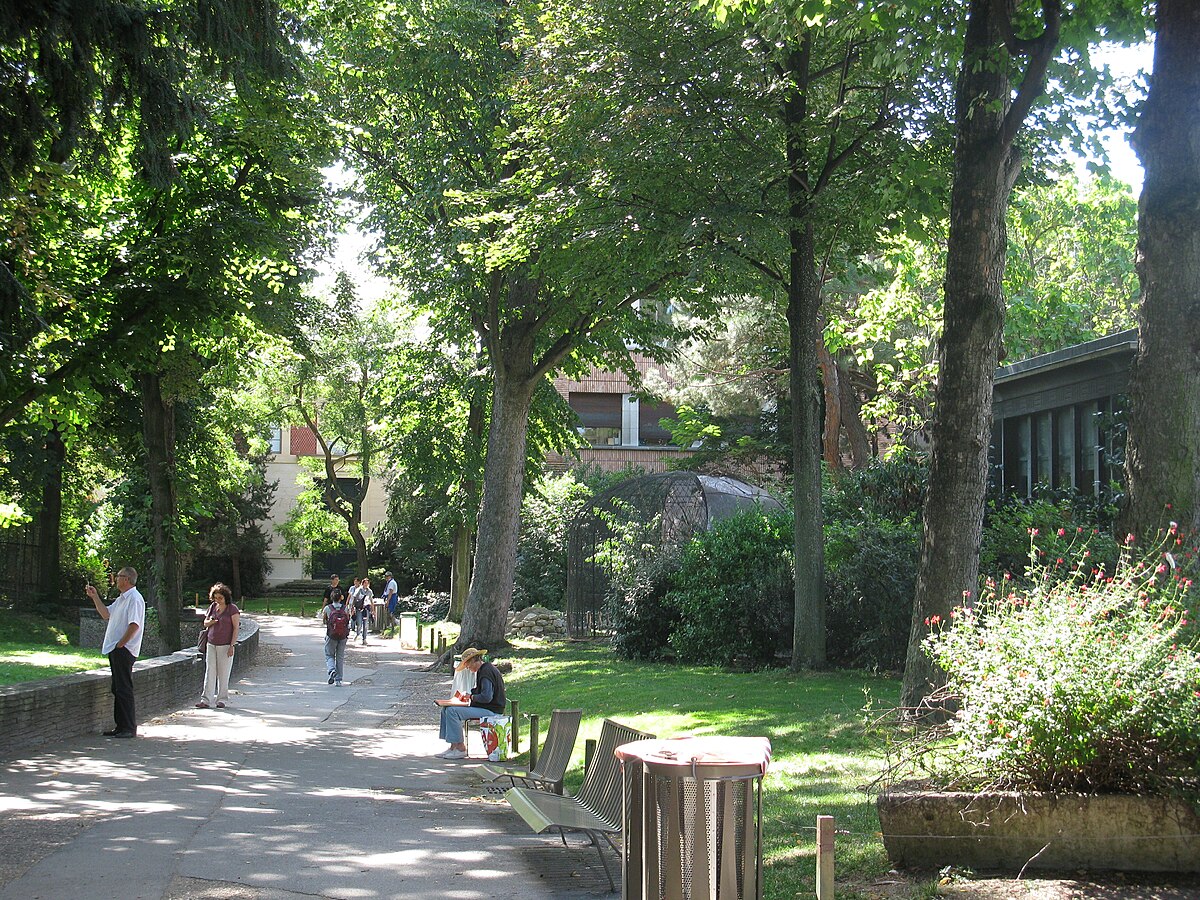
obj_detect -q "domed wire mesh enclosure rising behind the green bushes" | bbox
[566,472,782,637]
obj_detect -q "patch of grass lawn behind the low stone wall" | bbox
[0,610,108,684]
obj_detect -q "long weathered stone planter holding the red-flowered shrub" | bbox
[876,791,1200,872]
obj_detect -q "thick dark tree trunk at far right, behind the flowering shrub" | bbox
[1122,0,1200,539]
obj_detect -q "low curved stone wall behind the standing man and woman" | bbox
[0,616,258,760]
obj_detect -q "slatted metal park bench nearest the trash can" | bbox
[504,719,654,890]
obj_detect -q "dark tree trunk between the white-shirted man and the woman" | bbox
[142,372,184,652]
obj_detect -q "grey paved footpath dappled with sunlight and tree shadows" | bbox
[0,617,604,900]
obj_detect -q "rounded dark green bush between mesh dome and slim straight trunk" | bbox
[666,510,794,667]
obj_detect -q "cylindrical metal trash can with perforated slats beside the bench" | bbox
[617,737,770,900]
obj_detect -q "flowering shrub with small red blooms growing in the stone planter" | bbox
[926,526,1200,794]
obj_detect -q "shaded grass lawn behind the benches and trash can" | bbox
[505,642,899,900]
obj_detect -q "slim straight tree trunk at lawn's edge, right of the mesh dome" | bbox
[784,36,826,668]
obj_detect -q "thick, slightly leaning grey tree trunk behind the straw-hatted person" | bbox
[456,369,536,649]
